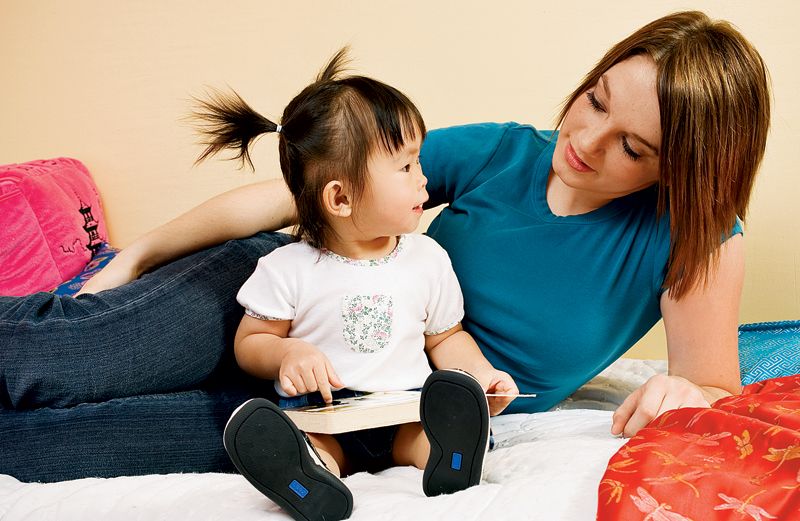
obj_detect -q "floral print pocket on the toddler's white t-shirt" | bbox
[342,295,393,353]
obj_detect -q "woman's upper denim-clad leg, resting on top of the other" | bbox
[0,233,291,410]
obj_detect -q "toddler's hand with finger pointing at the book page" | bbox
[278,340,344,403]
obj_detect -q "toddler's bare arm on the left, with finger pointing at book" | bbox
[233,315,344,403]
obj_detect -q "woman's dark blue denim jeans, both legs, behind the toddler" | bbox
[0,233,291,481]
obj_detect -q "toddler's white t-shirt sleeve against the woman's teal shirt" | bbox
[425,237,464,335]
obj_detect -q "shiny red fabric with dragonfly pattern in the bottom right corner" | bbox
[597,375,800,521]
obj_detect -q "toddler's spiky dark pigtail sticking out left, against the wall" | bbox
[191,91,278,169]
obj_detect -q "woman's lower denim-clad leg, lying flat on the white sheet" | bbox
[0,391,250,482]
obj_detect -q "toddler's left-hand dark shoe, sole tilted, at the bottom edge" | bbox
[223,398,353,521]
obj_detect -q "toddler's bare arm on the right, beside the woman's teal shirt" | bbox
[425,324,519,416]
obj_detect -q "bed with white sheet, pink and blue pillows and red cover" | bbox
[0,158,800,521]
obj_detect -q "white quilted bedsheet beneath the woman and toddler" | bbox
[0,359,665,521]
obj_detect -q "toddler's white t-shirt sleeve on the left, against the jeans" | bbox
[241,248,296,320]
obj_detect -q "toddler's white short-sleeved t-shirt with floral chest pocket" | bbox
[237,234,464,396]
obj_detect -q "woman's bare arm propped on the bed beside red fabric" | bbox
[611,235,744,436]
